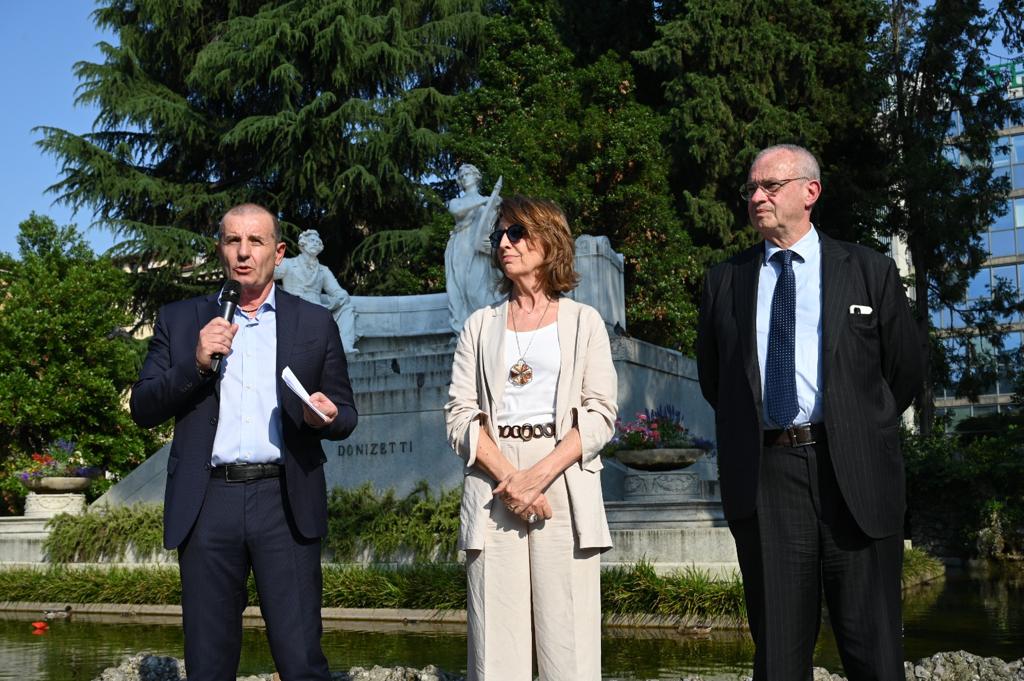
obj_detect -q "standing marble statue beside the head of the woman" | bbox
[444,164,502,334]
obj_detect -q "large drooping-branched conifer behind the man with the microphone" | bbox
[40,0,484,316]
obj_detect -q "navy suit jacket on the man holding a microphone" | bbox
[131,287,357,549]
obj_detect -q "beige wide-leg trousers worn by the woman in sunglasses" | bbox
[466,438,601,681]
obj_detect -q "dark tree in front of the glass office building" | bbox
[874,0,1024,435]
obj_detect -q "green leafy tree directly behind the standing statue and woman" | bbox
[450,0,700,350]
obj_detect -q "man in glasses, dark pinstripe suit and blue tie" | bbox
[697,144,923,681]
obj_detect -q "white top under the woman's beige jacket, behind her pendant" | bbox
[498,323,562,426]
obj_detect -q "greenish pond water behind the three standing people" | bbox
[0,571,1024,681]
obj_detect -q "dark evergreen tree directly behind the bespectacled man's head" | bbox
[636,0,886,250]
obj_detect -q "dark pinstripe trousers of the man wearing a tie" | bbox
[729,442,904,681]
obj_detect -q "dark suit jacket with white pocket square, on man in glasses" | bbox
[697,232,923,538]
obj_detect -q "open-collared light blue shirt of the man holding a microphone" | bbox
[210,287,282,466]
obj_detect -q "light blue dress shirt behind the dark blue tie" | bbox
[757,226,824,428]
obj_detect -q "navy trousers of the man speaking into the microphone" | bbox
[178,477,331,681]
